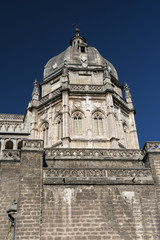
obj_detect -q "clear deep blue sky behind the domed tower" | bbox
[0,0,160,147]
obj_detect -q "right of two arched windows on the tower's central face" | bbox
[93,113,103,136]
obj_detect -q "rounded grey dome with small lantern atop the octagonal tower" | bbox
[43,29,118,81]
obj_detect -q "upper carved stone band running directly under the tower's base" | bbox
[45,148,144,160]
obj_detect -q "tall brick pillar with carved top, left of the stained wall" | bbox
[15,140,43,240]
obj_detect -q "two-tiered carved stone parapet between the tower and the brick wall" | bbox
[43,148,153,185]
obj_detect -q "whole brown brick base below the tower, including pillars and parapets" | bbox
[0,140,160,240]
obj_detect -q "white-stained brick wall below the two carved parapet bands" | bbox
[42,185,160,240]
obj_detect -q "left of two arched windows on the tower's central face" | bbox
[72,112,82,136]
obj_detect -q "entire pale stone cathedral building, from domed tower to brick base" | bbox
[0,29,160,240]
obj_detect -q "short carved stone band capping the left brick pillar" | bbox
[22,139,44,150]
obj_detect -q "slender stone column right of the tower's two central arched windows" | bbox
[106,93,118,148]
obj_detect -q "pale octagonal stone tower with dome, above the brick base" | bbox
[27,29,139,149]
